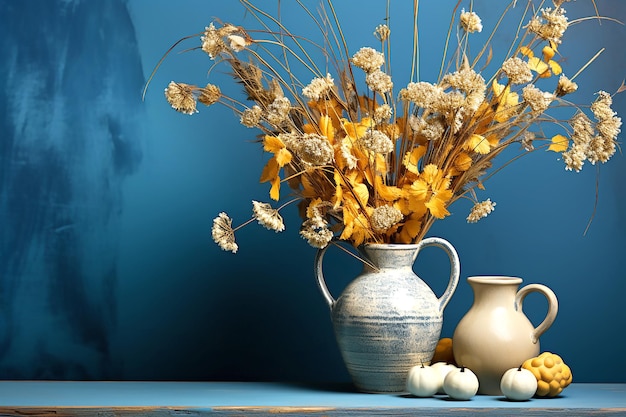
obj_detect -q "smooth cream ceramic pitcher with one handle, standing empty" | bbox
[452,276,558,395]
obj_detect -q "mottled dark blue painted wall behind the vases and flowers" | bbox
[0,0,626,382]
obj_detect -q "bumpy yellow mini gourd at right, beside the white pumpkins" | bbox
[522,352,572,397]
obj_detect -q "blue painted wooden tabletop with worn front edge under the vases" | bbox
[0,381,626,417]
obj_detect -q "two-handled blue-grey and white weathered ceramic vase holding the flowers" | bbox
[315,237,460,393]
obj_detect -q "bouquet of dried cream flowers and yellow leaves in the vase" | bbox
[152,0,621,252]
